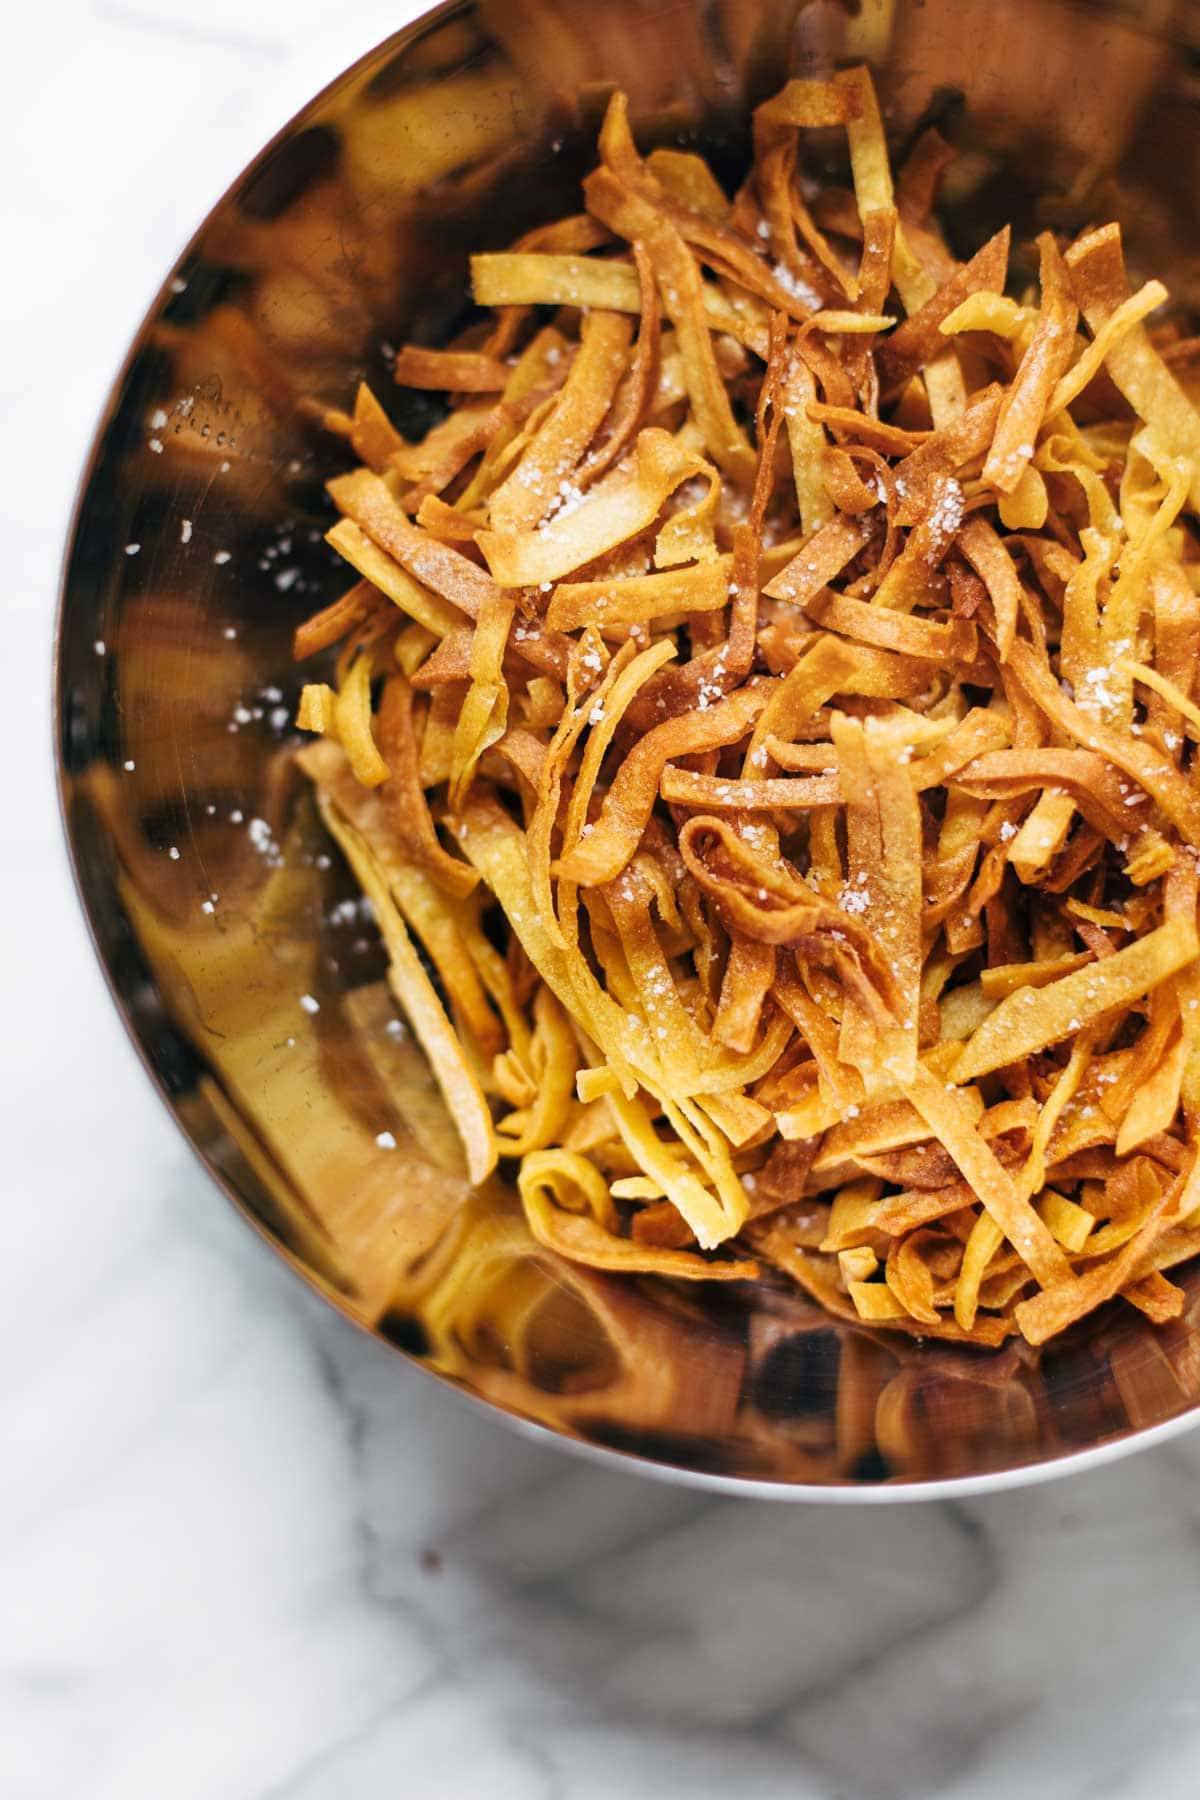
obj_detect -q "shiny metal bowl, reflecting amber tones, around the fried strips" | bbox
[58,0,1200,1498]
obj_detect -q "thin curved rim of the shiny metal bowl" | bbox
[50,0,1200,1507]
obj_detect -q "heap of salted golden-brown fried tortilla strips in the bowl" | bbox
[295,68,1200,1346]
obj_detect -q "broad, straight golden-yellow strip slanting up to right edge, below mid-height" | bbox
[954,918,1200,1082]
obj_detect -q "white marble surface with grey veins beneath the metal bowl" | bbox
[11,0,1200,1800]
